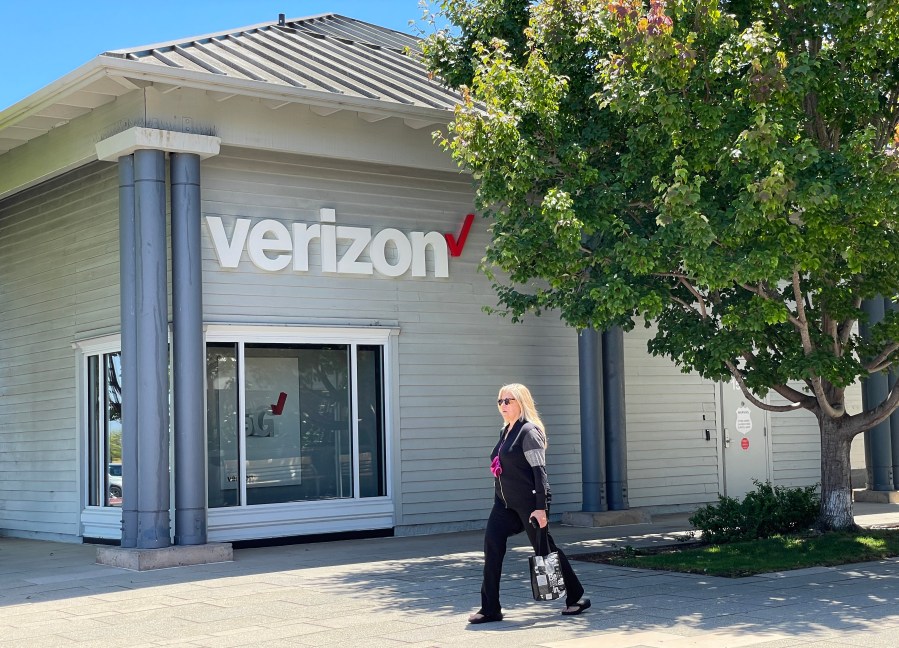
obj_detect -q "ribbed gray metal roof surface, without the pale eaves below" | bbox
[108,14,459,109]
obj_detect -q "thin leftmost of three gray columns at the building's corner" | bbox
[119,155,137,549]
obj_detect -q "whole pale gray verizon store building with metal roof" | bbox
[0,15,820,547]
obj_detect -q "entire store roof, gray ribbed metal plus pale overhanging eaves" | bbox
[0,14,461,155]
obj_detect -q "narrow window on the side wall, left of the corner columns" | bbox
[87,352,123,506]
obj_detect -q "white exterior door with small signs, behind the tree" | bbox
[721,380,770,499]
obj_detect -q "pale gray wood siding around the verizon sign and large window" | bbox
[202,149,581,532]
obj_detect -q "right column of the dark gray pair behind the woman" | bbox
[602,326,630,511]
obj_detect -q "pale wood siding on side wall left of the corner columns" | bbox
[0,163,119,539]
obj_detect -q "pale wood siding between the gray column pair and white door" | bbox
[624,323,719,508]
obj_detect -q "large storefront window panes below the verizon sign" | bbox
[206,342,386,508]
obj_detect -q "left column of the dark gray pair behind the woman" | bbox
[577,329,609,512]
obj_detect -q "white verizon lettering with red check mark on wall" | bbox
[206,209,474,277]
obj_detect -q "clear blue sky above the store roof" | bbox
[0,0,436,111]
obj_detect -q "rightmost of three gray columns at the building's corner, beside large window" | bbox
[170,153,207,545]
